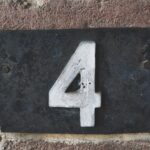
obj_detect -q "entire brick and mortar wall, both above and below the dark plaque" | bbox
[0,0,150,150]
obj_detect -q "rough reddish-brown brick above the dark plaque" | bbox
[0,0,150,29]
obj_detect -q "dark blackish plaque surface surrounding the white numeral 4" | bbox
[0,28,150,134]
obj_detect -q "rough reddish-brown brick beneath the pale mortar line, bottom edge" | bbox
[4,140,150,150]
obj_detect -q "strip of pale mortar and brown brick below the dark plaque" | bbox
[0,133,150,150]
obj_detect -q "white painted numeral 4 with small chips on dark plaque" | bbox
[49,41,101,127]
